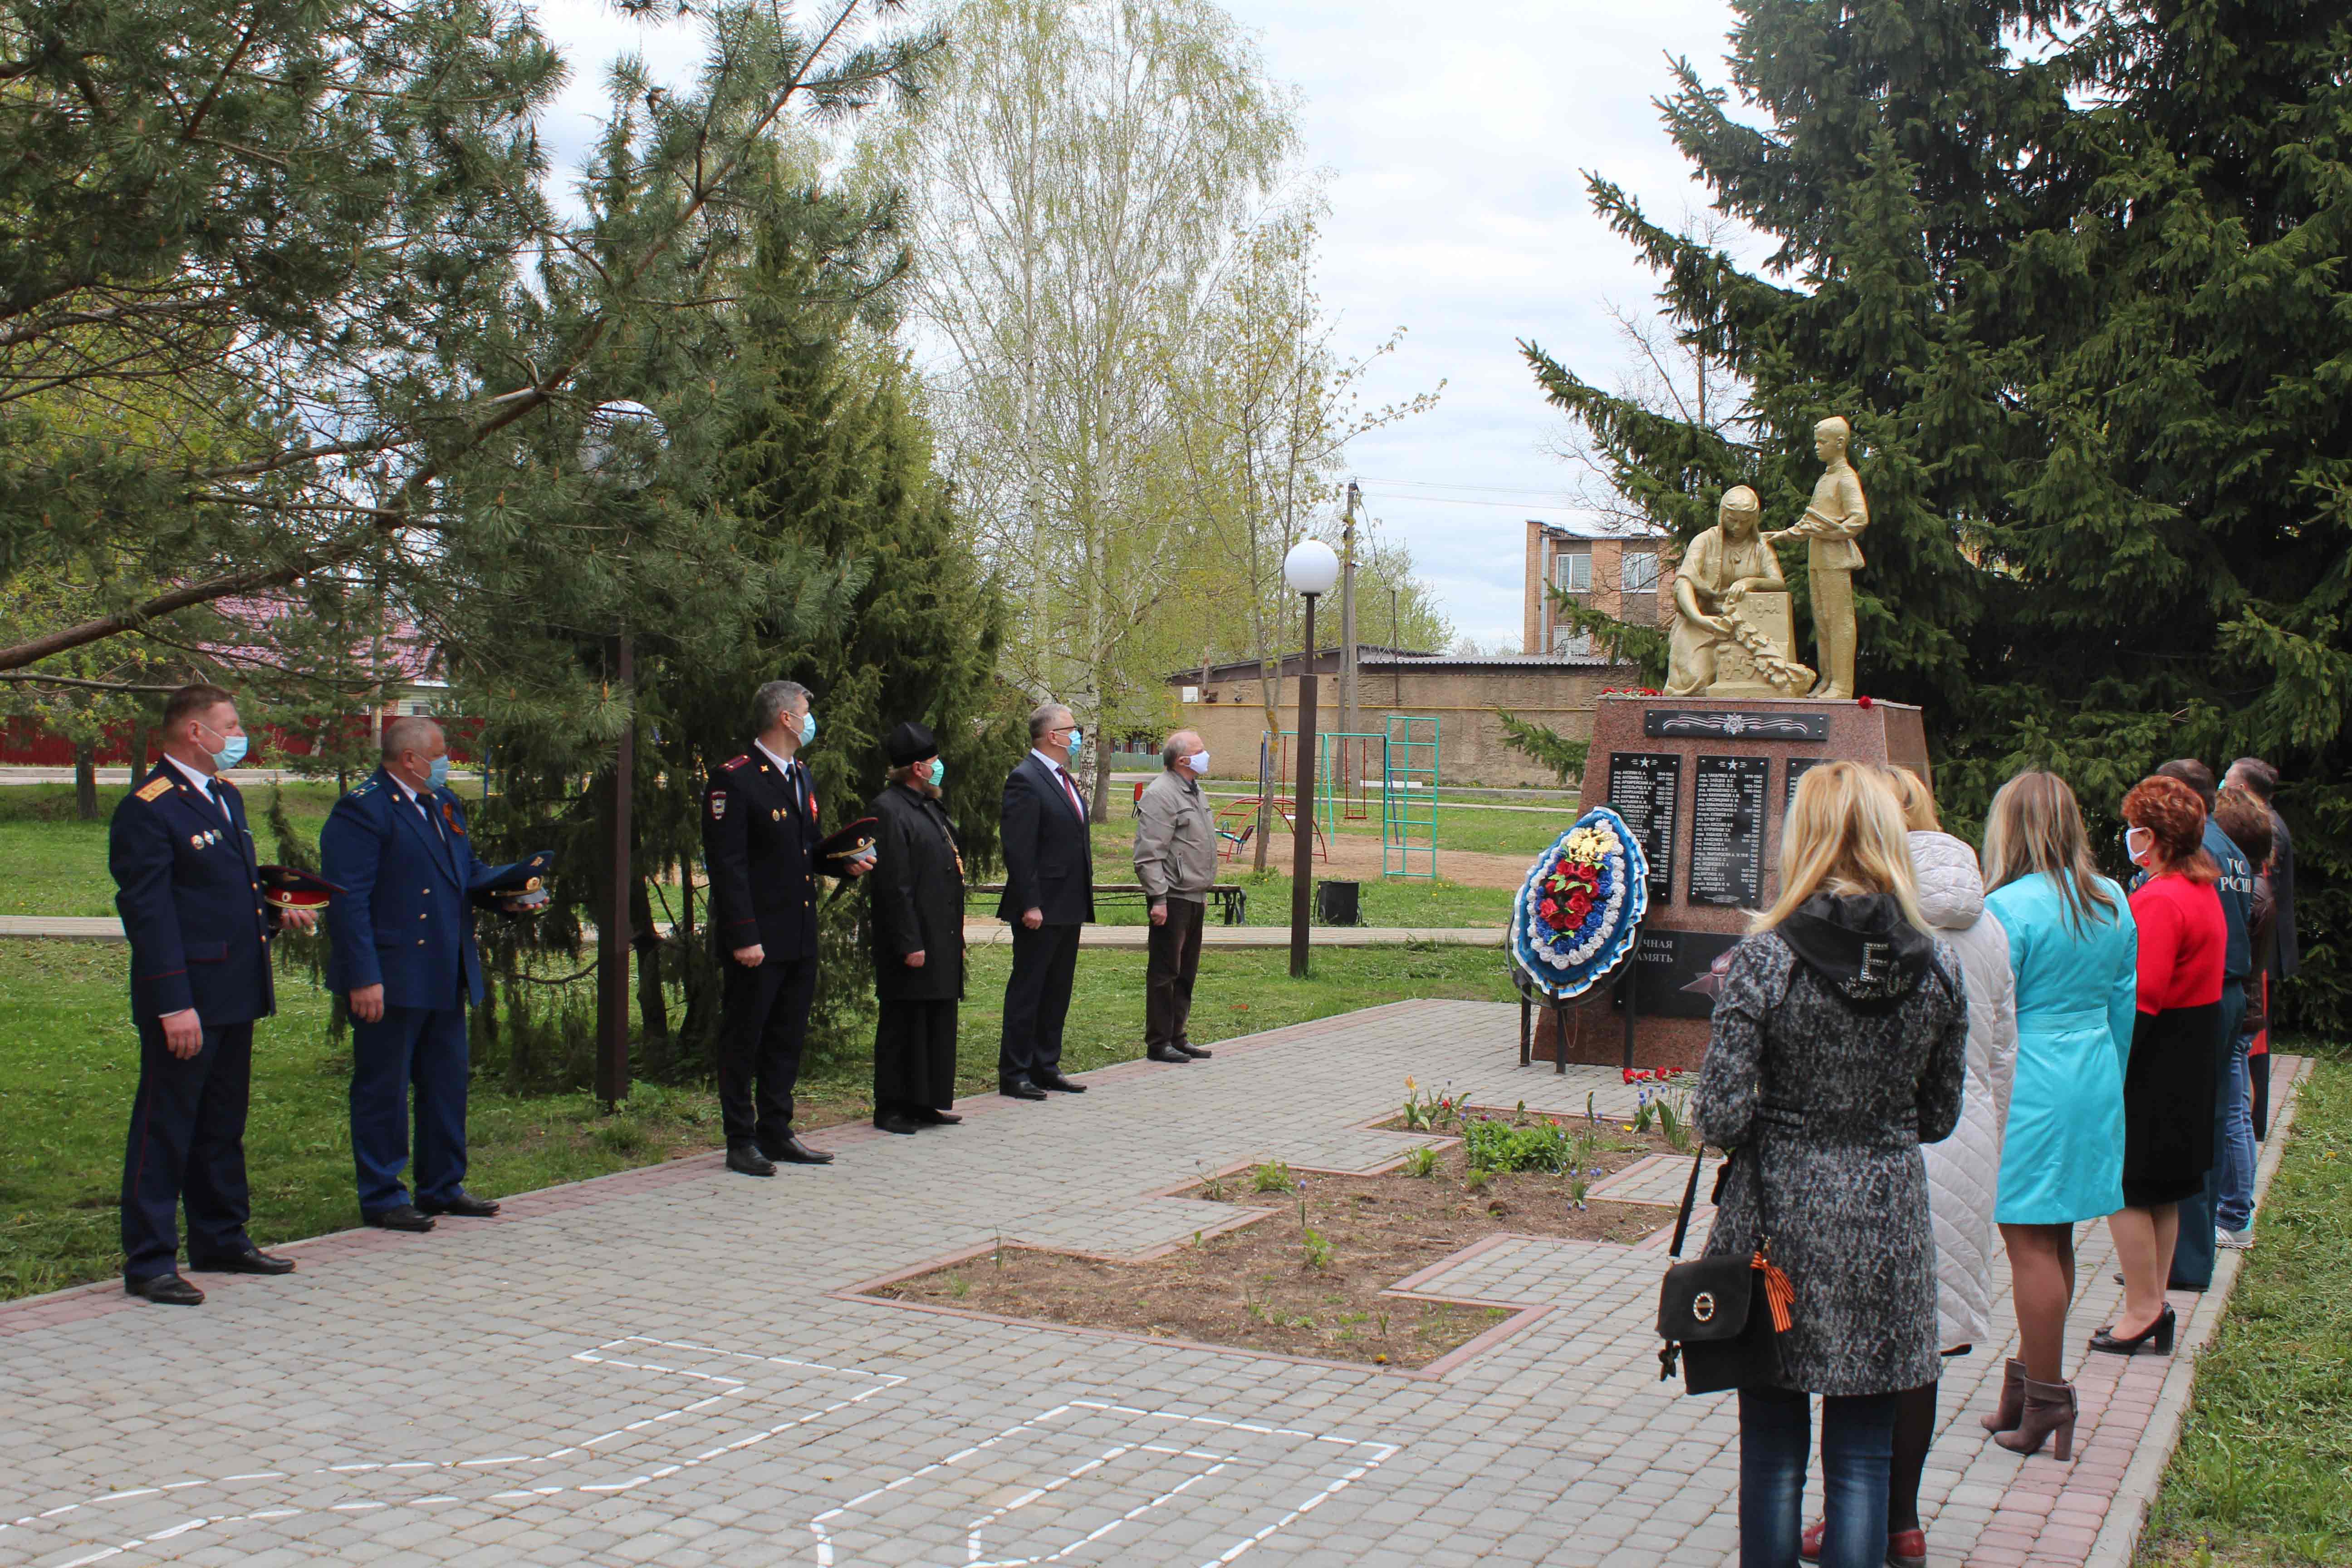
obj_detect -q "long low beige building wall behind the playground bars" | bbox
[1181,663,1637,788]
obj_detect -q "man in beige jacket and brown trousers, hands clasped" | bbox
[1136,729,1216,1063]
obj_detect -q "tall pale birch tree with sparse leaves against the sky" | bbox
[910,0,1298,816]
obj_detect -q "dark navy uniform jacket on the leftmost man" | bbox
[106,762,278,1027]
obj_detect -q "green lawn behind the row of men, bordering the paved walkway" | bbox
[0,941,1512,1300]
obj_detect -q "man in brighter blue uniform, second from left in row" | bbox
[318,717,539,1232]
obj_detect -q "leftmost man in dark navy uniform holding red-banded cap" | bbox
[106,684,313,1307]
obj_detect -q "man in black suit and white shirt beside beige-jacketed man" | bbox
[997,703,1094,1100]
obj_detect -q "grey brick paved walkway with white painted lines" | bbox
[0,1001,2291,1568]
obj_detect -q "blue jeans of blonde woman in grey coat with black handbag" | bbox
[1740,1389,1901,1568]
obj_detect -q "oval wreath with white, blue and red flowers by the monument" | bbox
[1508,806,1649,1001]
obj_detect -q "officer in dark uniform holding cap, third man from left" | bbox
[703,679,872,1176]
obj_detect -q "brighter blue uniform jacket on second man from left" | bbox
[318,769,513,1009]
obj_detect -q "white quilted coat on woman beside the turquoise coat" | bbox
[1910,832,2018,1352]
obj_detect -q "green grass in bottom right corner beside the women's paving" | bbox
[2136,1058,2352,1568]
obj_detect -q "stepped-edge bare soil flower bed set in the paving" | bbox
[872,1124,1675,1368]
